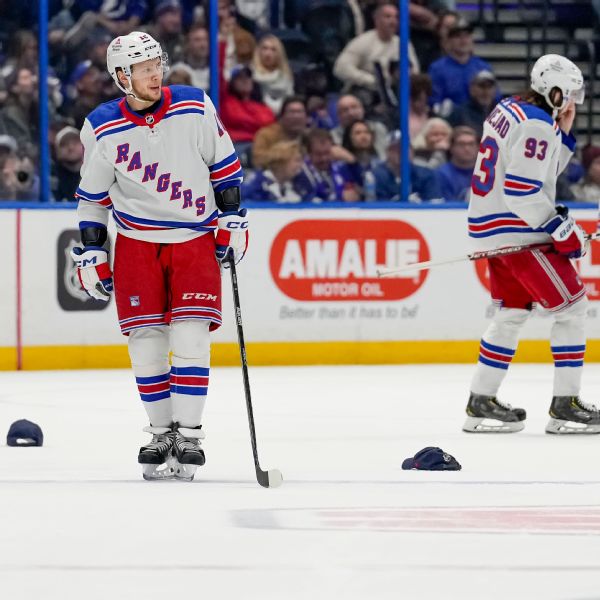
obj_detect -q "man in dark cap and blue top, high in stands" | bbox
[429,20,492,116]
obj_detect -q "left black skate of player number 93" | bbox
[463,393,527,433]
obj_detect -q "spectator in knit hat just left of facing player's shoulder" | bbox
[52,126,83,202]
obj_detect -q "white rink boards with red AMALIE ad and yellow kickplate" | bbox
[0,204,600,369]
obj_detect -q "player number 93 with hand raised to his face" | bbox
[463,54,600,433]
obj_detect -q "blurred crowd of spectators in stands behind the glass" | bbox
[0,0,600,203]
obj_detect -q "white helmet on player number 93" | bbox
[531,54,585,110]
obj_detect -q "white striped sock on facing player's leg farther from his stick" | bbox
[128,327,173,427]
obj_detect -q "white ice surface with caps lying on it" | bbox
[0,364,600,600]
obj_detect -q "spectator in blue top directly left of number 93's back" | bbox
[436,126,479,202]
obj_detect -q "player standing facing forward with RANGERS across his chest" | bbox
[73,32,248,480]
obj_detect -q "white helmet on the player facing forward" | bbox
[106,31,168,96]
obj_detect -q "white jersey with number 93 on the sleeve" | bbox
[468,98,575,250]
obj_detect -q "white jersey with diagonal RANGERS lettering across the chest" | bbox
[75,85,242,243]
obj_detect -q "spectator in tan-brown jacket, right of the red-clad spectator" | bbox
[252,96,307,169]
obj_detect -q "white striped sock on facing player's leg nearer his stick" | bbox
[171,320,210,427]
